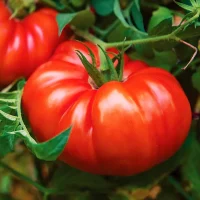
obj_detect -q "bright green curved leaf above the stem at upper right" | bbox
[148,7,173,32]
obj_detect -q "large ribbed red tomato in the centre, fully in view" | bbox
[22,41,191,176]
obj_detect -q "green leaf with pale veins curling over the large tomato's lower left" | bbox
[0,80,70,161]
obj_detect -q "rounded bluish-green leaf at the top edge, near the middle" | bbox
[91,0,115,16]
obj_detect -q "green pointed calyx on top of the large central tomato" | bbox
[76,44,124,88]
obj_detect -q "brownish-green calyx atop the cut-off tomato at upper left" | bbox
[7,0,36,19]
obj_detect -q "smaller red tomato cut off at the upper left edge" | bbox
[0,1,71,87]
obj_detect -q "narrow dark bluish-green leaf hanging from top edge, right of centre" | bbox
[131,0,145,32]
